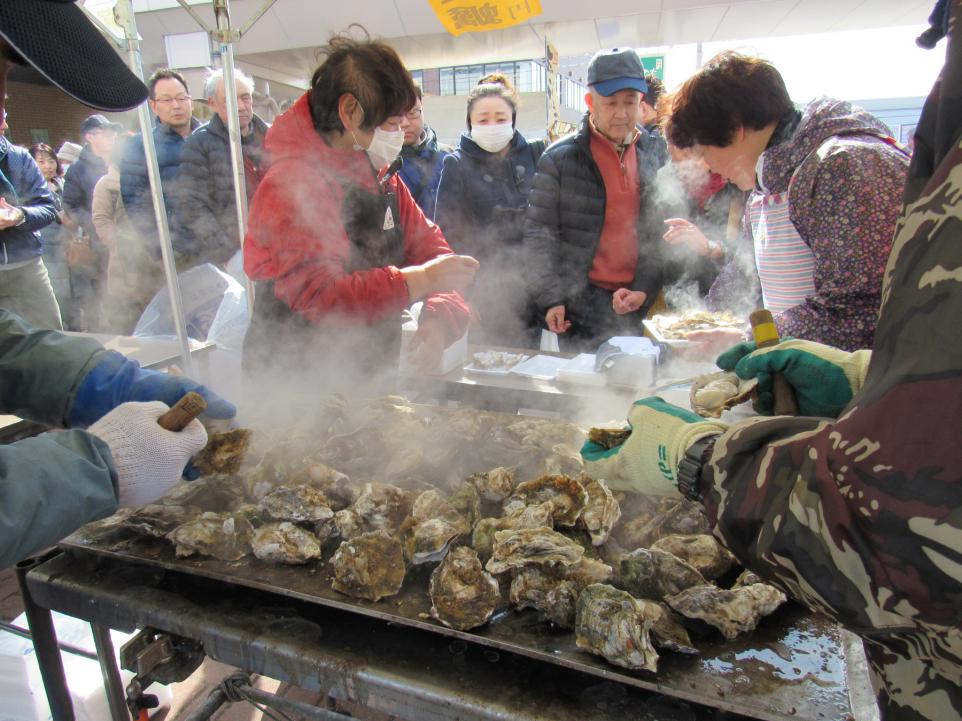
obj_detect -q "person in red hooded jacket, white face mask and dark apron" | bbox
[244,36,477,394]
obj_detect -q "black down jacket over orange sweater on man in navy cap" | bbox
[524,115,663,317]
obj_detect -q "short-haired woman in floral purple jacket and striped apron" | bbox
[668,52,909,350]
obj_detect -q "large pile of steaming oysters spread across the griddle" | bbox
[87,397,785,671]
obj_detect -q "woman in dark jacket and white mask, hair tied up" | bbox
[434,75,545,348]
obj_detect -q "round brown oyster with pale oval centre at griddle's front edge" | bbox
[429,546,501,631]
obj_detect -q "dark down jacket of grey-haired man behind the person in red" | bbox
[171,115,267,270]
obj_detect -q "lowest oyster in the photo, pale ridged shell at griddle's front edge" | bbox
[575,583,658,671]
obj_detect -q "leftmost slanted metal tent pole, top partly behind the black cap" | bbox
[114,0,194,377]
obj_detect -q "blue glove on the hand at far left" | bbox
[67,351,237,428]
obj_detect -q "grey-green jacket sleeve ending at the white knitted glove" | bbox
[0,431,117,568]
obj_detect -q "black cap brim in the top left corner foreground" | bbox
[0,0,147,111]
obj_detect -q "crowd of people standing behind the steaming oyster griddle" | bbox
[0,34,909,357]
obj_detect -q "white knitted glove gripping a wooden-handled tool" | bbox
[87,401,207,507]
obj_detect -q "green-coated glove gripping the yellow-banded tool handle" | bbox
[715,339,872,418]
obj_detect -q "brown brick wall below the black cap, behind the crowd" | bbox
[6,82,139,149]
